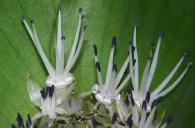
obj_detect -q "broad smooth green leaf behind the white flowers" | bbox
[0,0,195,128]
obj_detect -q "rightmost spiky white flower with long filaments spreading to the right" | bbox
[129,25,192,111]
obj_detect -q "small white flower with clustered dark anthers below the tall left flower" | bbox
[27,76,82,121]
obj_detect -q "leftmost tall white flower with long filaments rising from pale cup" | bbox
[22,9,86,104]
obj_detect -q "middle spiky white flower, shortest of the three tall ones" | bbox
[92,37,130,105]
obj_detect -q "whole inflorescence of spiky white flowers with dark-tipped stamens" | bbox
[12,9,192,128]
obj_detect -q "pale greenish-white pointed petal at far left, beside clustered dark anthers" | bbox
[27,75,41,107]
